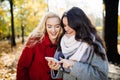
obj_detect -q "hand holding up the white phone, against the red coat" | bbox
[45,57,60,70]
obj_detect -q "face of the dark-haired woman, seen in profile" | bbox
[63,17,75,36]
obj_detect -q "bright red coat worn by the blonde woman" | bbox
[17,35,61,80]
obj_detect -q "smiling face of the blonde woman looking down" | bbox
[46,17,61,43]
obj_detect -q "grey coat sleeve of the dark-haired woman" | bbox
[70,48,108,80]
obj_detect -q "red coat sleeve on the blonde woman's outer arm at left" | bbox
[16,47,33,80]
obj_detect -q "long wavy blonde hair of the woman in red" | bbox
[26,12,62,46]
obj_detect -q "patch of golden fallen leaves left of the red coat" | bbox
[0,41,23,80]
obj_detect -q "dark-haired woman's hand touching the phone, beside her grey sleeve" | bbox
[59,58,75,68]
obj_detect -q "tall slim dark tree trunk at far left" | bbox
[10,0,16,47]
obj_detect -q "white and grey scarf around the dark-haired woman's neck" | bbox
[60,35,88,61]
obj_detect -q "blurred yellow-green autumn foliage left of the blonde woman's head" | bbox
[0,0,47,38]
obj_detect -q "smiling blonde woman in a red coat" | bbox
[17,12,62,80]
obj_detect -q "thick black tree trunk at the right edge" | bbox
[104,0,120,63]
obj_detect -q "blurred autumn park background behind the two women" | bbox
[0,0,120,80]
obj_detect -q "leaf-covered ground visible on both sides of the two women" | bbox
[0,41,120,80]
